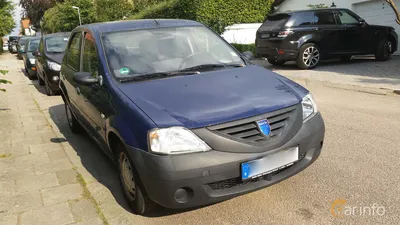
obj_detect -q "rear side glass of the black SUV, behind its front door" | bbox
[286,11,336,27]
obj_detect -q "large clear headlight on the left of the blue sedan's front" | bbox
[148,127,211,154]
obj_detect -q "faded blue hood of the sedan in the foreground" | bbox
[118,66,303,128]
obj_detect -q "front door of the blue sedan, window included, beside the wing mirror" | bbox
[78,32,111,140]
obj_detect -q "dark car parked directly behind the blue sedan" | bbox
[34,33,70,96]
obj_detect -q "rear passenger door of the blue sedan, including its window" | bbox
[60,32,82,116]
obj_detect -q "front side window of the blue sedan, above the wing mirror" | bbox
[82,33,99,77]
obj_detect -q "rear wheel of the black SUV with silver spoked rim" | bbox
[296,43,321,69]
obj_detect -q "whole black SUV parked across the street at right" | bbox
[256,9,398,69]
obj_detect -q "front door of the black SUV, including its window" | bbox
[336,9,371,54]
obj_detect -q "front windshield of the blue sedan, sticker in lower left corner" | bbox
[103,26,245,78]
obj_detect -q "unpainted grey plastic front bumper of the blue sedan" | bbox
[128,113,325,208]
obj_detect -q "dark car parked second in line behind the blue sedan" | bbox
[22,37,40,80]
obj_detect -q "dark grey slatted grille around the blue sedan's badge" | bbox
[208,106,296,142]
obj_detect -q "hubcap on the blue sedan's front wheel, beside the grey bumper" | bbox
[119,153,136,201]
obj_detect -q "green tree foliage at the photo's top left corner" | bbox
[0,0,15,38]
